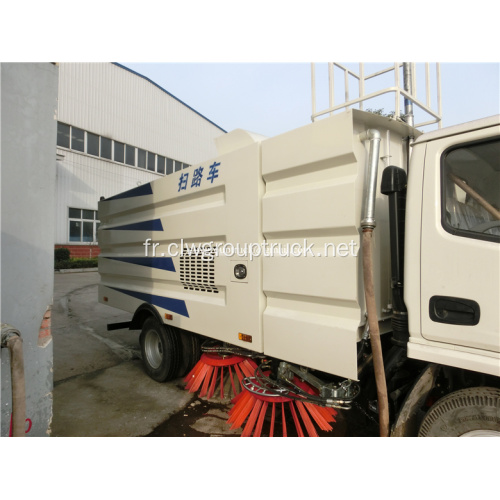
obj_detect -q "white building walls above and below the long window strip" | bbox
[55,63,224,243]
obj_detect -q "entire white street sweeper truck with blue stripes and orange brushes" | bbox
[98,66,500,436]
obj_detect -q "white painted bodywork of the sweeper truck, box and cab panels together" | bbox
[99,110,500,380]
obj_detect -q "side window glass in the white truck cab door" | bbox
[441,140,500,241]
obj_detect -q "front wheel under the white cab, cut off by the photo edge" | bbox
[418,387,500,437]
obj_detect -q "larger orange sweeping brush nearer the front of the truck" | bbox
[227,374,337,437]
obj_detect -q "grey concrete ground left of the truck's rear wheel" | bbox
[52,272,239,437]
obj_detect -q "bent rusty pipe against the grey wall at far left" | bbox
[0,323,26,437]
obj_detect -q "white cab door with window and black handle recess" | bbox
[421,125,500,352]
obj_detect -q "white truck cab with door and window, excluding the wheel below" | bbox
[405,116,500,376]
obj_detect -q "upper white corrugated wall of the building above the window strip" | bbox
[58,63,224,164]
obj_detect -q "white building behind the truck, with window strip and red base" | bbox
[55,63,225,257]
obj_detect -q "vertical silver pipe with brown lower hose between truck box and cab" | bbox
[359,129,389,437]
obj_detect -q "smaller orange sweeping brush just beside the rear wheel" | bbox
[184,353,257,399]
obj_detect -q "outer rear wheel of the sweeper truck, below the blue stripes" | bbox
[139,317,180,382]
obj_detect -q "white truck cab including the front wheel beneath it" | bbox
[392,115,500,436]
